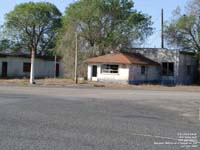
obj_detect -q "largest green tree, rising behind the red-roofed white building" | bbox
[58,0,152,77]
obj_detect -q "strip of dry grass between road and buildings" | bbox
[0,78,200,91]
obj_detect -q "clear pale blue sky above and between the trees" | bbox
[0,0,188,47]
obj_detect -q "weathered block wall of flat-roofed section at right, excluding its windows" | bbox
[125,48,197,84]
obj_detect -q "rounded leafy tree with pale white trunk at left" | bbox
[5,2,61,84]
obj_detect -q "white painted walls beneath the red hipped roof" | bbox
[88,64,160,83]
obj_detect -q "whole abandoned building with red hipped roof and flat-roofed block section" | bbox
[85,48,197,84]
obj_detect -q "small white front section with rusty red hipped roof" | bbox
[85,52,160,84]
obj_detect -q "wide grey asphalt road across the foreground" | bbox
[0,86,200,150]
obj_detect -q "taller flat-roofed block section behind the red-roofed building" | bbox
[126,48,197,84]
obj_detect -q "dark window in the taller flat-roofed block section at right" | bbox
[162,62,174,76]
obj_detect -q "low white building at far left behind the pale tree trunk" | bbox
[0,54,62,78]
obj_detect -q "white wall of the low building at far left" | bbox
[0,57,63,78]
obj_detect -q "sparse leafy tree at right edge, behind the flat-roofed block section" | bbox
[165,0,200,53]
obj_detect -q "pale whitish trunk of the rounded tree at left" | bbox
[30,48,35,84]
